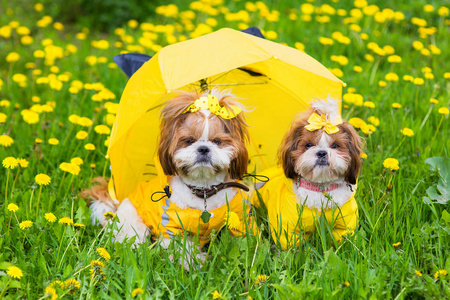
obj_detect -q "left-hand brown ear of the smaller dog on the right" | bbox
[278,120,307,179]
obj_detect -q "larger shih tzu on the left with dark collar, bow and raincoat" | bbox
[84,89,251,267]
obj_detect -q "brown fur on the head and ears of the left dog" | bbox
[158,92,248,179]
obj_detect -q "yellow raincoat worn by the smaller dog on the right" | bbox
[251,167,358,249]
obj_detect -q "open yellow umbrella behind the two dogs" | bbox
[108,28,343,200]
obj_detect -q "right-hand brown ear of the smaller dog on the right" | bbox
[339,122,363,184]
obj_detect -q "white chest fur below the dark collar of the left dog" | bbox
[170,176,237,211]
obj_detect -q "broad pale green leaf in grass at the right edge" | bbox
[423,157,450,204]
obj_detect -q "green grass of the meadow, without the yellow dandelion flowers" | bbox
[0,0,450,299]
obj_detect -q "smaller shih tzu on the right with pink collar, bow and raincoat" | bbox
[252,99,362,249]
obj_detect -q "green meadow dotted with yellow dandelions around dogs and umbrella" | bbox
[0,0,450,299]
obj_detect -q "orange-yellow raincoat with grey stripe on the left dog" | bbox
[128,176,252,247]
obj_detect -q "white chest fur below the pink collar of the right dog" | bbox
[293,181,356,209]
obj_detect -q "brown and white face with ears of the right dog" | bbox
[280,112,362,184]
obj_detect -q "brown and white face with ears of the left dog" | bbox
[158,93,248,180]
